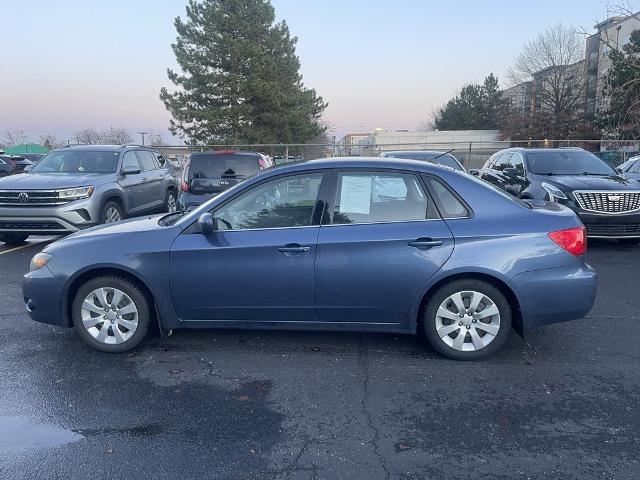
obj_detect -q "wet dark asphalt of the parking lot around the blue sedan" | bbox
[0,239,640,479]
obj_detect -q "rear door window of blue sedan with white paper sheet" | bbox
[333,172,428,224]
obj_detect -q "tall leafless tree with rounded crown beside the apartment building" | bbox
[508,23,586,139]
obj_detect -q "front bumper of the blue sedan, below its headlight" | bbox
[22,266,71,327]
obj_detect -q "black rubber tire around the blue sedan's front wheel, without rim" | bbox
[71,275,153,353]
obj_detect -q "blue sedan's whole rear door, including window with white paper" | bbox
[316,170,454,323]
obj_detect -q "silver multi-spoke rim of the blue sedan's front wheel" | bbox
[80,287,138,345]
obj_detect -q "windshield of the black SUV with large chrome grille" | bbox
[527,150,616,175]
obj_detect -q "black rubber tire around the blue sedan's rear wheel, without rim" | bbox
[423,279,512,360]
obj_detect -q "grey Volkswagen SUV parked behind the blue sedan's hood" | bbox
[0,145,177,244]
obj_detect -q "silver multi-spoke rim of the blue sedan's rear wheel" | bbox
[435,291,500,352]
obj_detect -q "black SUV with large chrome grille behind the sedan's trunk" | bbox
[477,148,640,243]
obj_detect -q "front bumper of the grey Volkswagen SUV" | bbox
[0,198,99,235]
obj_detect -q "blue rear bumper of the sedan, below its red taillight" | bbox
[511,264,597,330]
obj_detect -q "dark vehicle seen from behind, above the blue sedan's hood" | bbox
[178,150,275,210]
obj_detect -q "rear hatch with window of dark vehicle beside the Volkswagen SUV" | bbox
[187,152,260,195]
